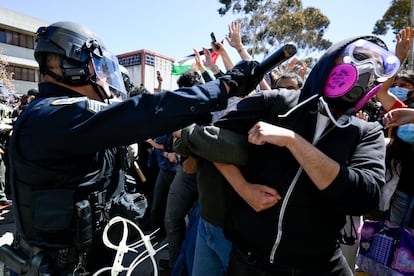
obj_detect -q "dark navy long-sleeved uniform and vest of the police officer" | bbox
[10,80,227,271]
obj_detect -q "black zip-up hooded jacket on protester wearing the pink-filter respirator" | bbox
[187,35,385,267]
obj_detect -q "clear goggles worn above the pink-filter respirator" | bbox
[344,39,400,80]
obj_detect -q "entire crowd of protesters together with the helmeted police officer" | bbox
[0,15,414,276]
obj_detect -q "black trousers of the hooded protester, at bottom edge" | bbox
[227,246,353,276]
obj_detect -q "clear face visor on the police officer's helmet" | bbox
[92,49,127,99]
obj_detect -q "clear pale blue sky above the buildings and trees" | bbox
[0,0,395,62]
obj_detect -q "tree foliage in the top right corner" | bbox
[372,0,414,35]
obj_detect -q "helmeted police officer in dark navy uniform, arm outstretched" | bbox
[6,22,261,275]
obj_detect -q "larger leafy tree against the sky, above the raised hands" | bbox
[218,0,332,57]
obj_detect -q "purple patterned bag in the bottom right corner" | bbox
[356,220,414,276]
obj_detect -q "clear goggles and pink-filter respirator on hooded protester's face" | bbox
[321,39,400,127]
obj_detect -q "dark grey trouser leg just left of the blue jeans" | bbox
[165,165,198,267]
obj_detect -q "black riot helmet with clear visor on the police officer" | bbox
[34,21,127,100]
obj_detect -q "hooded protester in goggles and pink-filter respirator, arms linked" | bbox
[175,36,400,276]
